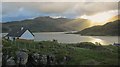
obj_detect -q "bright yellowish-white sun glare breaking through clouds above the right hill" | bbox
[80,10,117,25]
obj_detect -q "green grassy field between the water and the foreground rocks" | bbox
[2,40,119,65]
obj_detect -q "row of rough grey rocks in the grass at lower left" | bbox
[3,50,69,67]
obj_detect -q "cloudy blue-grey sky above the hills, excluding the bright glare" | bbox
[2,2,118,22]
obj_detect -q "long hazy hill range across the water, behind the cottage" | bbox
[2,16,89,32]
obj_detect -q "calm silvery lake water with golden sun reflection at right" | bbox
[3,32,118,45]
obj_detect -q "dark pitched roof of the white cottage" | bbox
[6,27,34,37]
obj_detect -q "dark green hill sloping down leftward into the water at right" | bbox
[76,20,120,36]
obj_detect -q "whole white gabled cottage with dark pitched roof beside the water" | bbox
[5,27,34,41]
